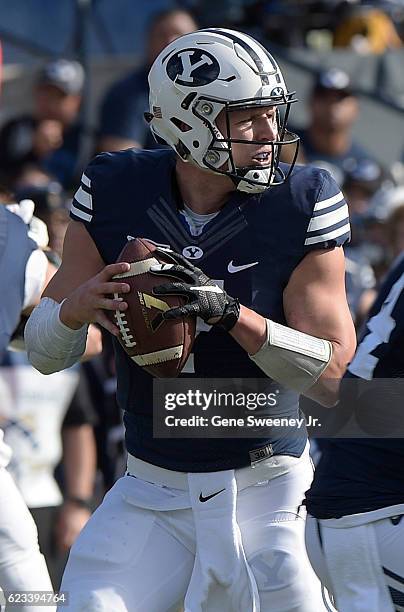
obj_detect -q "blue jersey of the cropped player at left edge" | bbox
[0,204,37,359]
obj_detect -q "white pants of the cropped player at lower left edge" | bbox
[0,466,56,612]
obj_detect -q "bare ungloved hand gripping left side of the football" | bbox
[59,262,130,336]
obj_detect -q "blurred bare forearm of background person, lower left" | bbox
[63,425,96,499]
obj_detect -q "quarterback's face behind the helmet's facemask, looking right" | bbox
[216,106,278,168]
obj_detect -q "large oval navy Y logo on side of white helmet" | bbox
[167,49,220,87]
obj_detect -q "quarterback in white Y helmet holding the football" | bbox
[26,29,355,612]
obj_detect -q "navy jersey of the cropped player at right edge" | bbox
[306,256,404,518]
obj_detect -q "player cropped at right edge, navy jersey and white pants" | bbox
[306,254,404,612]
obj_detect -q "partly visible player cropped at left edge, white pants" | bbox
[0,200,56,612]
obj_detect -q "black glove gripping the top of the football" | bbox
[150,249,240,331]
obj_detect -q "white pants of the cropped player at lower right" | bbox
[306,506,404,612]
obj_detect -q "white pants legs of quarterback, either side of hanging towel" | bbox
[60,444,324,612]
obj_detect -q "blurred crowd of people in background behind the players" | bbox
[0,0,404,588]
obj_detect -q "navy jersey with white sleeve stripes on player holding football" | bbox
[71,150,349,471]
